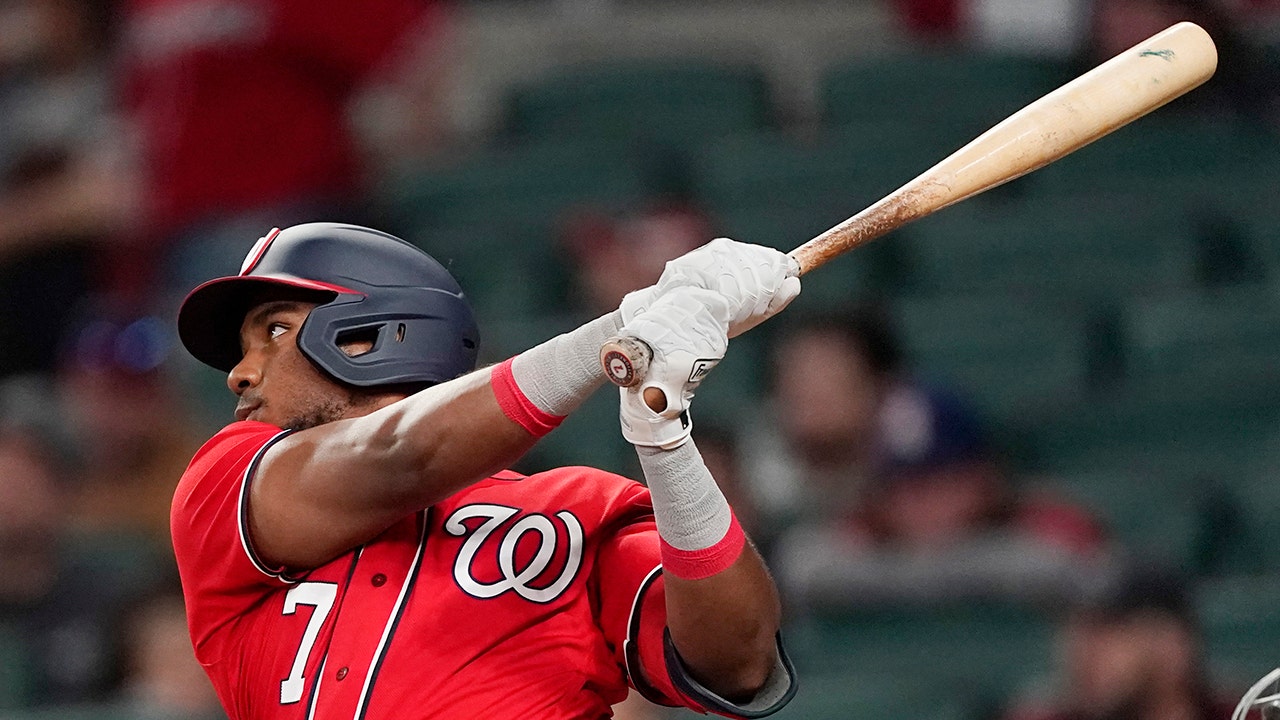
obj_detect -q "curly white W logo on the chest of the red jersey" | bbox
[444,503,582,603]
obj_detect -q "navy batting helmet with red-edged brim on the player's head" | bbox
[178,223,479,387]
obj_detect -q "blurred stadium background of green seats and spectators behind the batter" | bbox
[0,0,1280,720]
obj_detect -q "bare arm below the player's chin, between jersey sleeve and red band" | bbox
[248,370,535,570]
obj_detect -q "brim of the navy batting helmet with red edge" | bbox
[178,275,362,373]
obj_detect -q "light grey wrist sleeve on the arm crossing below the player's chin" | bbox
[511,310,622,418]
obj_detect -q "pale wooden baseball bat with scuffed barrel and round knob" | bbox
[600,22,1217,411]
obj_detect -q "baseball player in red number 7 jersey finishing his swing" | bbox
[172,223,800,720]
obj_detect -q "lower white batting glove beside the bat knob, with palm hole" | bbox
[618,287,728,450]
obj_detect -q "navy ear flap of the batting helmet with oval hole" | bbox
[298,288,479,387]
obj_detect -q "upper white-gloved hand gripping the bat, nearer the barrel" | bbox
[621,237,800,337]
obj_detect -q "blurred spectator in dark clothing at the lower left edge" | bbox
[0,379,166,706]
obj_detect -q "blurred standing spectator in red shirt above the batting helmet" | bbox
[108,0,460,295]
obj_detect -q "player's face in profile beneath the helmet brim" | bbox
[227,300,358,429]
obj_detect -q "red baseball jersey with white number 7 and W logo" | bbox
[172,421,791,720]
